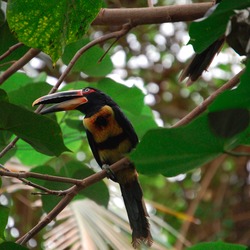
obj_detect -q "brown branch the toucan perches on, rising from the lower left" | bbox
[16,158,130,245]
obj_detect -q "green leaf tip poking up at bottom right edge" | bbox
[186,242,248,250]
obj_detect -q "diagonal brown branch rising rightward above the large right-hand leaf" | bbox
[172,69,245,128]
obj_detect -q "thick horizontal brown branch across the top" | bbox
[92,2,213,26]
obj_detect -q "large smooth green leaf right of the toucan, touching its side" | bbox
[130,113,250,176]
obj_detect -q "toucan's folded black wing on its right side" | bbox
[112,105,138,148]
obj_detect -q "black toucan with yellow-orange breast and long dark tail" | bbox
[33,87,153,248]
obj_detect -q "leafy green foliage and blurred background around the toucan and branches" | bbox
[0,0,250,250]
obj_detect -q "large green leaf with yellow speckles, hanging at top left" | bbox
[7,0,102,62]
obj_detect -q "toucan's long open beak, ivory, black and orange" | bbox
[32,90,88,114]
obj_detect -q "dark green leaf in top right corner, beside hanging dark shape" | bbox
[189,0,250,53]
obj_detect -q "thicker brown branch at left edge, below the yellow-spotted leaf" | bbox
[0,49,40,85]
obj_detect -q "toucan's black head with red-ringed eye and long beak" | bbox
[32,87,115,115]
